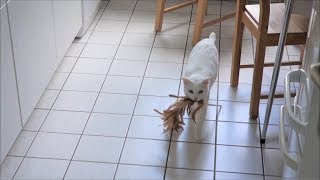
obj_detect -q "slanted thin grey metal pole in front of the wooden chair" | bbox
[260,0,294,143]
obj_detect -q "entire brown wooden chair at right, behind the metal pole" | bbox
[230,0,308,119]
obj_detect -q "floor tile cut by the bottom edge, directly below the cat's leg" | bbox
[165,168,213,180]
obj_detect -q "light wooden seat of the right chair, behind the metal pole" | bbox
[243,3,309,46]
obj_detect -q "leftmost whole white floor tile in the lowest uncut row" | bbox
[27,132,80,159]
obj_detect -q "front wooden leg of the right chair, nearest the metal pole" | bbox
[250,39,266,119]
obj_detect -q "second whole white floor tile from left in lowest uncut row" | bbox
[73,135,124,163]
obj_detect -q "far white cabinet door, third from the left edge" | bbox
[53,0,82,62]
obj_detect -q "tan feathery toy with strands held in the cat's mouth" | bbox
[154,95,204,132]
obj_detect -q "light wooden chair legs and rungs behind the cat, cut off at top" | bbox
[154,0,236,45]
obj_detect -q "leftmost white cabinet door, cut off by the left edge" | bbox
[0,5,22,164]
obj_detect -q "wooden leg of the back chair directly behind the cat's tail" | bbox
[192,0,208,46]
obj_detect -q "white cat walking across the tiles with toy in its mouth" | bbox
[182,32,219,141]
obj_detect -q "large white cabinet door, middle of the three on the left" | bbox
[7,0,58,123]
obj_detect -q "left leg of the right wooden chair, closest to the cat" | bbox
[230,1,245,87]
